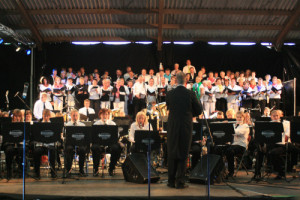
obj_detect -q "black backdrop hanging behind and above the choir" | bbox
[0,42,296,109]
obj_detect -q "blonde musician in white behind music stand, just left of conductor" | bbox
[129,112,153,153]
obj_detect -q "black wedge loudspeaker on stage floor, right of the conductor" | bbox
[190,154,225,184]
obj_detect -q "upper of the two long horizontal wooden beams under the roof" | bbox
[0,8,292,16]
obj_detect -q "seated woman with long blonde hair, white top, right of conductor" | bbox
[225,111,250,177]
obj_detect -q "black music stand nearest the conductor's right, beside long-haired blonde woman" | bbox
[210,122,234,145]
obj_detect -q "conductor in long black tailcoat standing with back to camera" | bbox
[166,72,202,189]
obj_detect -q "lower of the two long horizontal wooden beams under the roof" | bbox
[34,24,283,30]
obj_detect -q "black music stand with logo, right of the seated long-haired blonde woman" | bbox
[255,121,283,144]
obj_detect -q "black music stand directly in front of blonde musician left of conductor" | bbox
[134,130,160,152]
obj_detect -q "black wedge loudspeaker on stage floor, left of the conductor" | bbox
[122,153,160,183]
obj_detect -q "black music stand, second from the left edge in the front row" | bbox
[31,122,63,175]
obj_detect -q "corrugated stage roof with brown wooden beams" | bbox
[0,0,300,49]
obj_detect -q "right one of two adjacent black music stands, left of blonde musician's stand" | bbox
[91,125,118,177]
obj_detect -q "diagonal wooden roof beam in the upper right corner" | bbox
[275,1,300,49]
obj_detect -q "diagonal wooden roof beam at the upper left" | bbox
[15,0,43,47]
